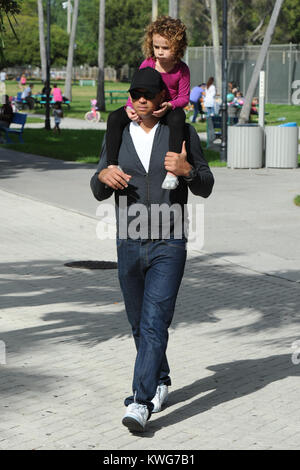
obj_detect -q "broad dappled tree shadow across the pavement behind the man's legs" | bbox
[0,255,300,350]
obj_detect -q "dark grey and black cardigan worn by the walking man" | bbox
[91,123,214,239]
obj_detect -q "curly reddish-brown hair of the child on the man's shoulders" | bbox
[143,16,187,62]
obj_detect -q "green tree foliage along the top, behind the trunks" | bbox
[0,0,300,67]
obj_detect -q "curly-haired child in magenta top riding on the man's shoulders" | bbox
[106,16,190,189]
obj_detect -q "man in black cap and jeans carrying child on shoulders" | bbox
[91,67,214,431]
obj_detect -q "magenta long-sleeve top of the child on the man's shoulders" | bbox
[126,57,190,109]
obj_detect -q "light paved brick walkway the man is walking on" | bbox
[0,141,300,450]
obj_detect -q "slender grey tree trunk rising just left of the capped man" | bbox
[97,0,105,111]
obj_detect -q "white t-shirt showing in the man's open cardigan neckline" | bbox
[129,121,159,173]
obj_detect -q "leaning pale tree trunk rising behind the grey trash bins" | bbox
[239,0,283,124]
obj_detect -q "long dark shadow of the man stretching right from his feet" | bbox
[142,354,300,437]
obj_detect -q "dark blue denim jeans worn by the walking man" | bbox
[117,239,186,413]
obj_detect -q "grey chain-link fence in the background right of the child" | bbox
[185,44,300,104]
